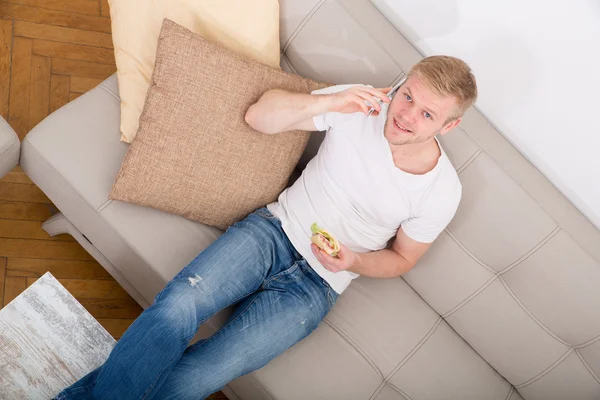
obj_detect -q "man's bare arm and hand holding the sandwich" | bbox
[311,227,431,278]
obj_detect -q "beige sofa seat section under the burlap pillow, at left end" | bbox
[22,75,222,306]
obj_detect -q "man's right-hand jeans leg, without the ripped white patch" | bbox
[150,260,337,400]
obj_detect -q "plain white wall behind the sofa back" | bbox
[372,0,600,228]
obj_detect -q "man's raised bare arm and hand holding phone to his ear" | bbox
[245,85,390,134]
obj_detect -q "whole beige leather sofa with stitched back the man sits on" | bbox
[21,0,600,400]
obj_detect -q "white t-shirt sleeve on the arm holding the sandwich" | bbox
[401,184,462,243]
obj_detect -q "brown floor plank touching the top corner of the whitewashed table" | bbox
[6,258,113,280]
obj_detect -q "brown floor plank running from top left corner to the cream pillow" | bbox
[0,1,110,33]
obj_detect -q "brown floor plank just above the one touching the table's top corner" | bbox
[0,238,93,261]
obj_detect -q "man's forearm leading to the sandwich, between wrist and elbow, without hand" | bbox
[348,249,413,278]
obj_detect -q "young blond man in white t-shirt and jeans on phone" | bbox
[57,56,477,400]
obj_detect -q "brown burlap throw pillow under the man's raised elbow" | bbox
[110,19,327,229]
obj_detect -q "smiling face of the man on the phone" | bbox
[383,75,460,145]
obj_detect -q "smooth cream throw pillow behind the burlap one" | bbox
[109,0,280,143]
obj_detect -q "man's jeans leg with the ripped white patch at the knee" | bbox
[57,214,294,400]
